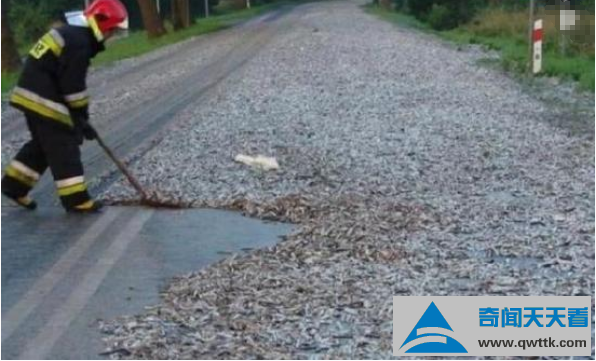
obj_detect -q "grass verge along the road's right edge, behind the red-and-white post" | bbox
[364,5,595,92]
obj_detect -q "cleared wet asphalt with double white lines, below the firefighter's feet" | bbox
[2,207,290,359]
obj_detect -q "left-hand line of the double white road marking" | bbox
[2,208,122,342]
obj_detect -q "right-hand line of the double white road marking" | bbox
[18,211,153,360]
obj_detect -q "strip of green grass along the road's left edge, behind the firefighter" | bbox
[2,1,290,95]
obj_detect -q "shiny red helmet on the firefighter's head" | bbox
[85,0,128,34]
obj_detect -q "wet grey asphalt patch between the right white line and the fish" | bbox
[57,207,293,359]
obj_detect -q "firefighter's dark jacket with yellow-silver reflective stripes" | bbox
[10,25,104,129]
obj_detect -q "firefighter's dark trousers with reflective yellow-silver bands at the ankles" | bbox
[2,114,91,208]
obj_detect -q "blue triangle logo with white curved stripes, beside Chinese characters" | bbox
[399,302,468,353]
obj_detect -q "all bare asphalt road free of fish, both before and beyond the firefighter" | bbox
[2,8,290,359]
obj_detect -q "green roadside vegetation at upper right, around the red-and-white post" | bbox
[365,4,595,92]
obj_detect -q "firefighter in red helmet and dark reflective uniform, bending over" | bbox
[2,0,128,213]
